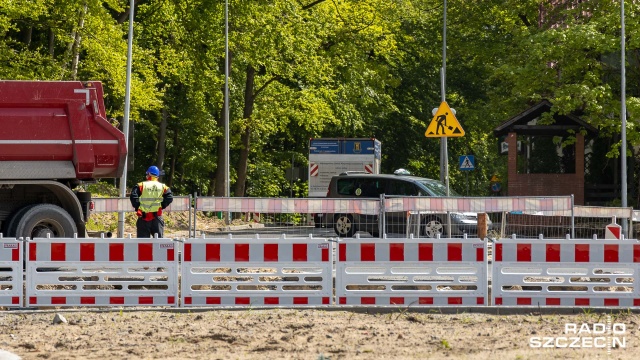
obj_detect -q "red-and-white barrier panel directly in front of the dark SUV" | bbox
[336,238,488,306]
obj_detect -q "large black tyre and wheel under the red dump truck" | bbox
[15,204,78,239]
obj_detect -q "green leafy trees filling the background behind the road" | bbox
[0,0,640,197]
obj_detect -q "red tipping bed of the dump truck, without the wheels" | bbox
[0,81,126,180]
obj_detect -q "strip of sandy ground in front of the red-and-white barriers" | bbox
[0,309,640,359]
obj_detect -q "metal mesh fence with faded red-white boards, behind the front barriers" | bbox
[94,196,640,239]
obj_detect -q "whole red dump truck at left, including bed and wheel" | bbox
[0,81,127,238]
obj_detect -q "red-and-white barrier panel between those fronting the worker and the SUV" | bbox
[181,237,333,307]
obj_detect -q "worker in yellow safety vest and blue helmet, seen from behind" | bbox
[129,166,173,238]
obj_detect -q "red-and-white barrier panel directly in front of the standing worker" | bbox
[26,238,179,306]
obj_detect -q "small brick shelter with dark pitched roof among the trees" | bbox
[493,100,598,205]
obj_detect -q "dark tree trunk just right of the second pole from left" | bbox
[235,65,256,197]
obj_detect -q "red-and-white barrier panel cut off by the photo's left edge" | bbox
[0,238,23,306]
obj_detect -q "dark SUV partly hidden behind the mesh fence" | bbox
[324,172,488,238]
